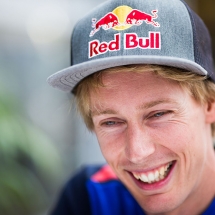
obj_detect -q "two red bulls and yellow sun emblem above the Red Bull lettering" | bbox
[90,5,160,37]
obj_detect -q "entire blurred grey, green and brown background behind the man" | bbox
[0,0,215,215]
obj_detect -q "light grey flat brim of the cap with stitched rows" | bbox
[48,56,207,92]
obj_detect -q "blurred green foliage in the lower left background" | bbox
[0,90,61,215]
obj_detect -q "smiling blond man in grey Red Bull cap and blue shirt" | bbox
[49,0,215,215]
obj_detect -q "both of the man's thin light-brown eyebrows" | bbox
[91,99,178,117]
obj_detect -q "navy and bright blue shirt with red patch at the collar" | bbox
[51,165,215,215]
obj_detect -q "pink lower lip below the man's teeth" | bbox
[129,161,176,191]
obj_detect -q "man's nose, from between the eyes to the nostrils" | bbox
[125,125,155,164]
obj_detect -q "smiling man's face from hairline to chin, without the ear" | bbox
[90,72,211,213]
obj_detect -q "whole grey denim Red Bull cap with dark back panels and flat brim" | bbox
[48,0,215,92]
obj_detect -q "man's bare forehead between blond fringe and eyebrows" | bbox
[90,72,185,108]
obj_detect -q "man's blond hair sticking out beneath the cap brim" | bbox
[73,65,215,136]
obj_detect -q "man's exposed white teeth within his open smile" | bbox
[132,161,173,184]
